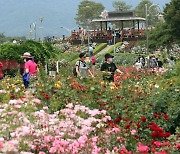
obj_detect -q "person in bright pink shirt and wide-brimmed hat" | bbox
[22,52,37,88]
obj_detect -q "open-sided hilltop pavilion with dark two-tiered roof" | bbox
[92,10,146,41]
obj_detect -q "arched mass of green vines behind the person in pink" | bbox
[0,40,55,63]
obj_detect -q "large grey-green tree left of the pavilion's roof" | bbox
[75,0,105,28]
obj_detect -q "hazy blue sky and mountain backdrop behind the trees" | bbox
[0,0,170,37]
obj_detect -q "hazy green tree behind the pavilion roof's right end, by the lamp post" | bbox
[135,0,159,26]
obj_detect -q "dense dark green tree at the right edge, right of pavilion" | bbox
[149,0,180,48]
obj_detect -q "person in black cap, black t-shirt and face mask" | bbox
[100,53,123,82]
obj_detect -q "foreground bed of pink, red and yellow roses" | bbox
[0,63,180,154]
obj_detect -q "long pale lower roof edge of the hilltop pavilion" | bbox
[92,17,146,22]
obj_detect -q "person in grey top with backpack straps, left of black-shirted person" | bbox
[76,52,94,79]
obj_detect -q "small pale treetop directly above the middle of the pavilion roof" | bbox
[112,1,132,11]
